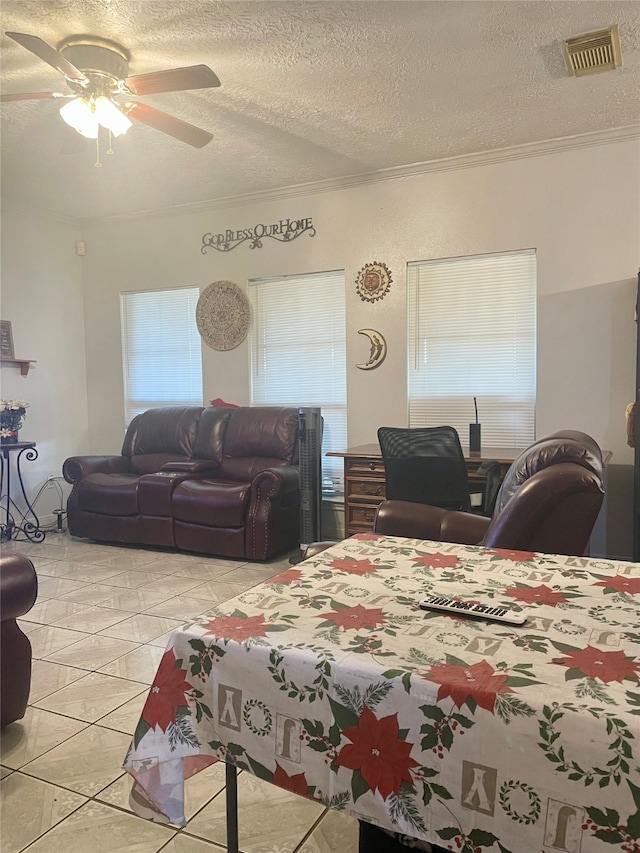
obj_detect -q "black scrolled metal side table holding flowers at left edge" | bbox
[0,441,45,542]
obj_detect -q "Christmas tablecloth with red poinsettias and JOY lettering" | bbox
[124,534,640,853]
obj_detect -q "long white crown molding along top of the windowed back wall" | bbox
[84,125,640,224]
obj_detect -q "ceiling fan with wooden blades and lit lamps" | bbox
[0,32,220,148]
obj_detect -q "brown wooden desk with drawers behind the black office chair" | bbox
[327,443,521,536]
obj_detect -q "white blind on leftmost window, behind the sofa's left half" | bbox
[120,287,202,425]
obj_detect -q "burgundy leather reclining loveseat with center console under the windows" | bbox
[63,406,300,560]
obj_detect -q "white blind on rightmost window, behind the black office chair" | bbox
[407,249,536,449]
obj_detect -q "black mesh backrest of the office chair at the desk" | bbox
[378,426,471,512]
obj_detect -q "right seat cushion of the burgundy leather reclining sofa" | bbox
[171,480,251,527]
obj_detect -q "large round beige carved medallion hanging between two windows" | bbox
[196,281,249,350]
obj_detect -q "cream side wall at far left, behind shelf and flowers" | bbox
[0,206,88,524]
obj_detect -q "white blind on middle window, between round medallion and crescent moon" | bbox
[249,270,347,492]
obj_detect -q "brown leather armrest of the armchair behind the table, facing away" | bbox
[373,501,490,545]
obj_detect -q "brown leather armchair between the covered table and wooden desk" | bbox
[373,430,604,556]
